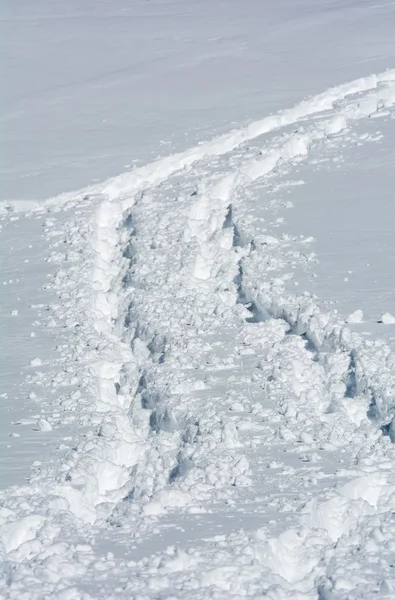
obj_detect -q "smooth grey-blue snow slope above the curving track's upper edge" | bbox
[0,0,395,200]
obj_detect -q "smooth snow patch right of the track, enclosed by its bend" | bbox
[272,117,395,348]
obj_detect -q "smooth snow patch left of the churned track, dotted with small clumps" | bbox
[0,216,67,488]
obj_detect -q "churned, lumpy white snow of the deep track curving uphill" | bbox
[0,71,395,600]
